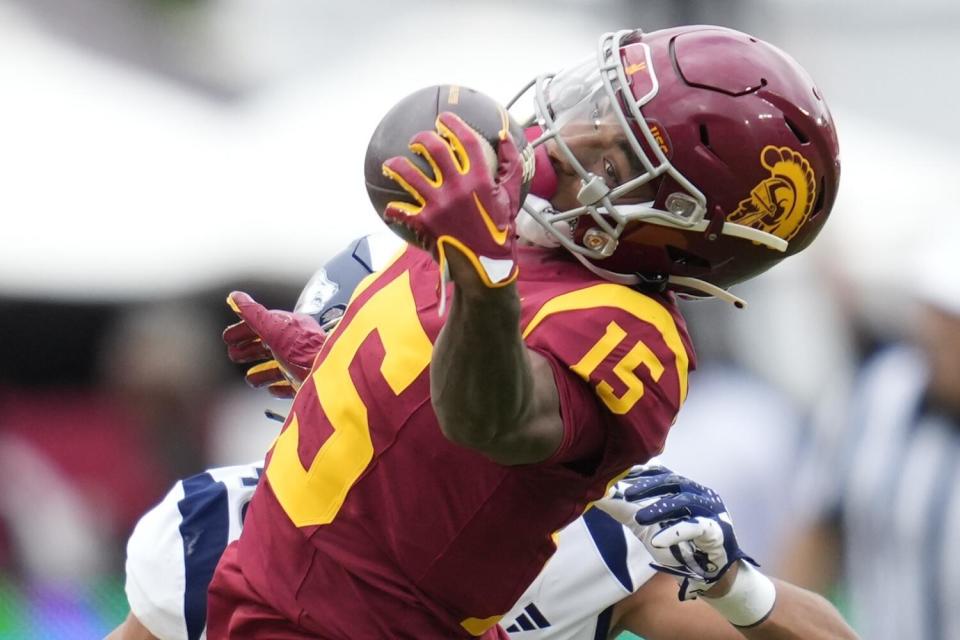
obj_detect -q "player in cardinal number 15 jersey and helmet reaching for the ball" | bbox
[199,27,839,639]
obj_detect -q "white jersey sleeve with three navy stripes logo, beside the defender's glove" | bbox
[500,508,655,640]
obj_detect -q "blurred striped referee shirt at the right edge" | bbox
[796,347,960,640]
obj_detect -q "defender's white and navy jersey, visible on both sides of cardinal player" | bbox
[126,462,654,640]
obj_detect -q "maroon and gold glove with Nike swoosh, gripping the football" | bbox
[383,112,523,287]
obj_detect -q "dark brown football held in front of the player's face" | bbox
[363,84,533,244]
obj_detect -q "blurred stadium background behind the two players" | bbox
[0,0,960,640]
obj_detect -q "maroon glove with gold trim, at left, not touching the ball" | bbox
[223,291,326,398]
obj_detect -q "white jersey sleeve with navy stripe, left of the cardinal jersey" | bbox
[126,462,263,640]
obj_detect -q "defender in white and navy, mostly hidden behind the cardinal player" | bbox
[111,235,855,640]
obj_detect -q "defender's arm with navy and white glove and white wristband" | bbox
[596,466,857,640]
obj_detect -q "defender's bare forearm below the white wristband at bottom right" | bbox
[740,580,858,640]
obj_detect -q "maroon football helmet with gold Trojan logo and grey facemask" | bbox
[512,26,840,304]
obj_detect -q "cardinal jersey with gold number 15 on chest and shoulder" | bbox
[209,247,694,640]
